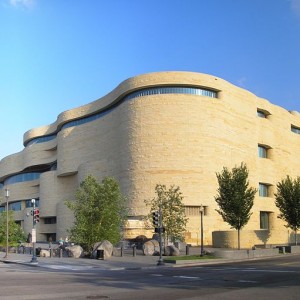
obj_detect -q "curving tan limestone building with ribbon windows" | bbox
[0,72,300,247]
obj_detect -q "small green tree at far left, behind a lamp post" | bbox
[0,210,26,246]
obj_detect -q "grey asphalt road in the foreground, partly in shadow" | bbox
[0,255,300,300]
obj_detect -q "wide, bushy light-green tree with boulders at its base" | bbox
[65,175,127,253]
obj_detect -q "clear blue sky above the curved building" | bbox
[0,0,300,159]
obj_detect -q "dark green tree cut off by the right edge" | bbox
[275,176,300,245]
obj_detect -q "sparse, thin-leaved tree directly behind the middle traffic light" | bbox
[145,184,187,242]
